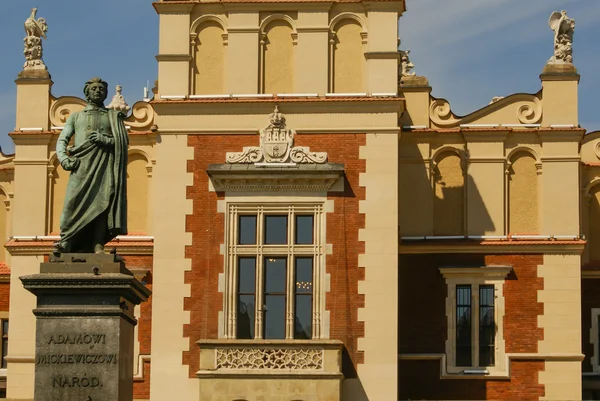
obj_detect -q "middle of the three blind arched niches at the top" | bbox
[263,19,294,94]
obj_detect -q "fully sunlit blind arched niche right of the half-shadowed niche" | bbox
[508,151,539,234]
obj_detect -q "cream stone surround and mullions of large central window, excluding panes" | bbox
[219,198,333,341]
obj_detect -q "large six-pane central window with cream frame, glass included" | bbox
[224,203,324,340]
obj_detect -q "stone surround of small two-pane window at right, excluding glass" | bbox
[439,266,512,378]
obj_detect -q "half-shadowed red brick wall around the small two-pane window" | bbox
[398,254,544,400]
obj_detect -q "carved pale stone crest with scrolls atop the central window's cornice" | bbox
[227,106,327,164]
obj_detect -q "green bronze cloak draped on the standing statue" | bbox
[60,110,129,247]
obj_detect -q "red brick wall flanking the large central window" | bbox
[183,134,365,377]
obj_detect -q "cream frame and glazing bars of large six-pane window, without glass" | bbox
[223,202,326,340]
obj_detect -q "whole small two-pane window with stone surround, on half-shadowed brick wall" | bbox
[440,266,512,375]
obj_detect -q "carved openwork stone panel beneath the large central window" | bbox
[217,348,323,370]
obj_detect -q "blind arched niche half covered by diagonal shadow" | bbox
[433,152,465,235]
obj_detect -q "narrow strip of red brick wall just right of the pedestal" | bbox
[124,255,153,399]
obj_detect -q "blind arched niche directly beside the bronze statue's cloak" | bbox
[127,153,149,234]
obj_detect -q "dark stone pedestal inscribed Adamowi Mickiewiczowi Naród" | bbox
[20,254,150,401]
